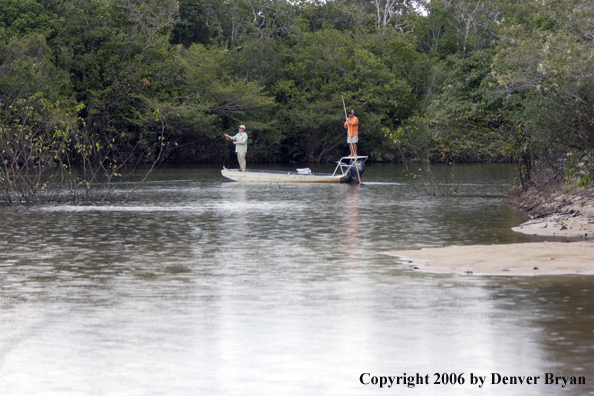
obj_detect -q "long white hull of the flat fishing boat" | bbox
[221,169,349,183]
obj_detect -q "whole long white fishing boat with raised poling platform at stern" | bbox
[221,156,367,183]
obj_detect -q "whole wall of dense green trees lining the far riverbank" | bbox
[0,0,594,201]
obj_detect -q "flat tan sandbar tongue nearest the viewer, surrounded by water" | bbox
[386,242,594,276]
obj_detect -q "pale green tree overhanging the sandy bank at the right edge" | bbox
[494,0,594,186]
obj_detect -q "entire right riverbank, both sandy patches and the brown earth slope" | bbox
[387,183,594,276]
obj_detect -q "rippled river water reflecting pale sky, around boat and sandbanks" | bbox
[0,164,594,396]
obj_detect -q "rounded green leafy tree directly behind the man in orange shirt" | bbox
[275,28,414,161]
